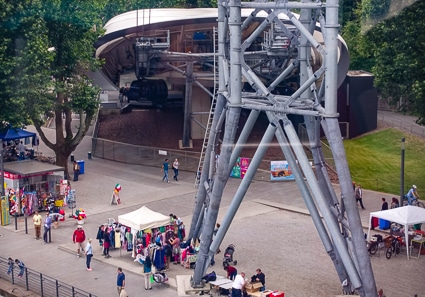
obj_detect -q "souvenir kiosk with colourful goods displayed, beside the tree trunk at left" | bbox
[0,160,65,220]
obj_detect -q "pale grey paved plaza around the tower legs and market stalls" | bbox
[0,121,425,297]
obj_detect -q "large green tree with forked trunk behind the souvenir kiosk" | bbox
[1,0,106,176]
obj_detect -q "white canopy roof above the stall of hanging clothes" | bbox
[118,206,170,258]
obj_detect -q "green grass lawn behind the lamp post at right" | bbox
[344,128,425,195]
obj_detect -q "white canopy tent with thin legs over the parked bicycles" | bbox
[367,205,425,259]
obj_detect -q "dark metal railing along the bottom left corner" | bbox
[0,257,97,297]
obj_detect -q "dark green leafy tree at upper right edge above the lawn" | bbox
[365,1,425,125]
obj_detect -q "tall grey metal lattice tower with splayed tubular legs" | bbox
[189,0,377,297]
